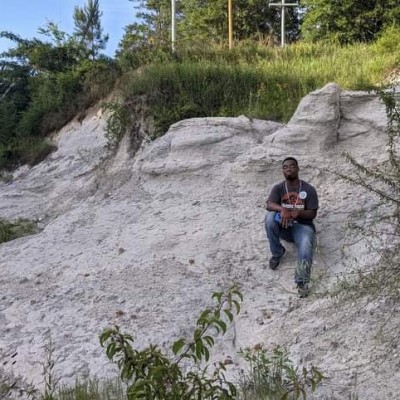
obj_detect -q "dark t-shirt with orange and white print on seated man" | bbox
[268,180,318,224]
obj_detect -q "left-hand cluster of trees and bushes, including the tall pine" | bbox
[0,0,118,169]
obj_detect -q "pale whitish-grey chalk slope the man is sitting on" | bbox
[0,84,400,399]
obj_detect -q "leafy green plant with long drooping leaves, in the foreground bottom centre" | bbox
[100,285,243,400]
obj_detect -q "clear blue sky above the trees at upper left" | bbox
[0,0,138,56]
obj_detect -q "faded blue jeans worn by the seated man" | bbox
[265,211,315,283]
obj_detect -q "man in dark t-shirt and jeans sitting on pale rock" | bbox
[265,157,318,297]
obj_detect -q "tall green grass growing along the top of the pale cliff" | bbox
[117,31,400,137]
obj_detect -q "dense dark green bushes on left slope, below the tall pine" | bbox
[0,59,120,169]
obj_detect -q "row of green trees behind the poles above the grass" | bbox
[120,0,400,51]
